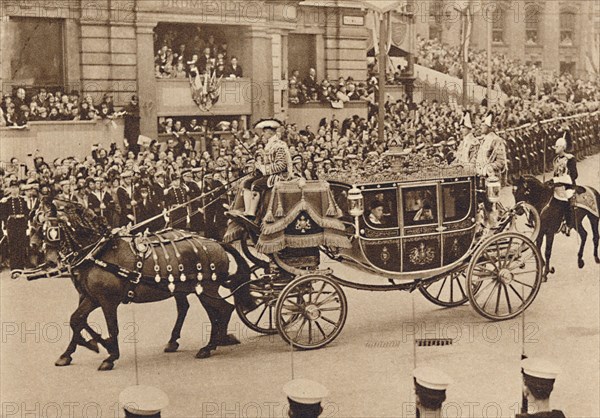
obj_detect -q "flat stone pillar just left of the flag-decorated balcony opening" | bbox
[136,23,158,139]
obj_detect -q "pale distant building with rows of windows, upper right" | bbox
[415,0,600,77]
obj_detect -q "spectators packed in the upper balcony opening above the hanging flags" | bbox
[154,31,244,78]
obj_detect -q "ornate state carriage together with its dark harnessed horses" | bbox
[13,156,543,370]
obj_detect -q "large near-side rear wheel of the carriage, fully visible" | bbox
[467,232,543,320]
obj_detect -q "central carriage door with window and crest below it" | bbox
[401,182,442,272]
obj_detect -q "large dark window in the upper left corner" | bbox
[2,17,65,90]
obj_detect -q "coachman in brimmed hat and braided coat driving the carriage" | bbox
[244,119,292,219]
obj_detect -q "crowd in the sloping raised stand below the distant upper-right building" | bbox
[416,35,600,103]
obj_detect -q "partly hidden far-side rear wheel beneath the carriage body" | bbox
[419,266,482,308]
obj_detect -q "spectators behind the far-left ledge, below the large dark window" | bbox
[0,87,118,127]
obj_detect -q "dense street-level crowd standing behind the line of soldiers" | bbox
[3,85,598,199]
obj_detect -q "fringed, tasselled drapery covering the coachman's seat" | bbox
[256,179,351,254]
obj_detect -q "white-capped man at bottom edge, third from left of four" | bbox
[413,367,452,418]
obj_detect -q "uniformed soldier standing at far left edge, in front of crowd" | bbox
[0,180,29,270]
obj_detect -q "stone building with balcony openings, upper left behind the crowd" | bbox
[0,0,380,137]
